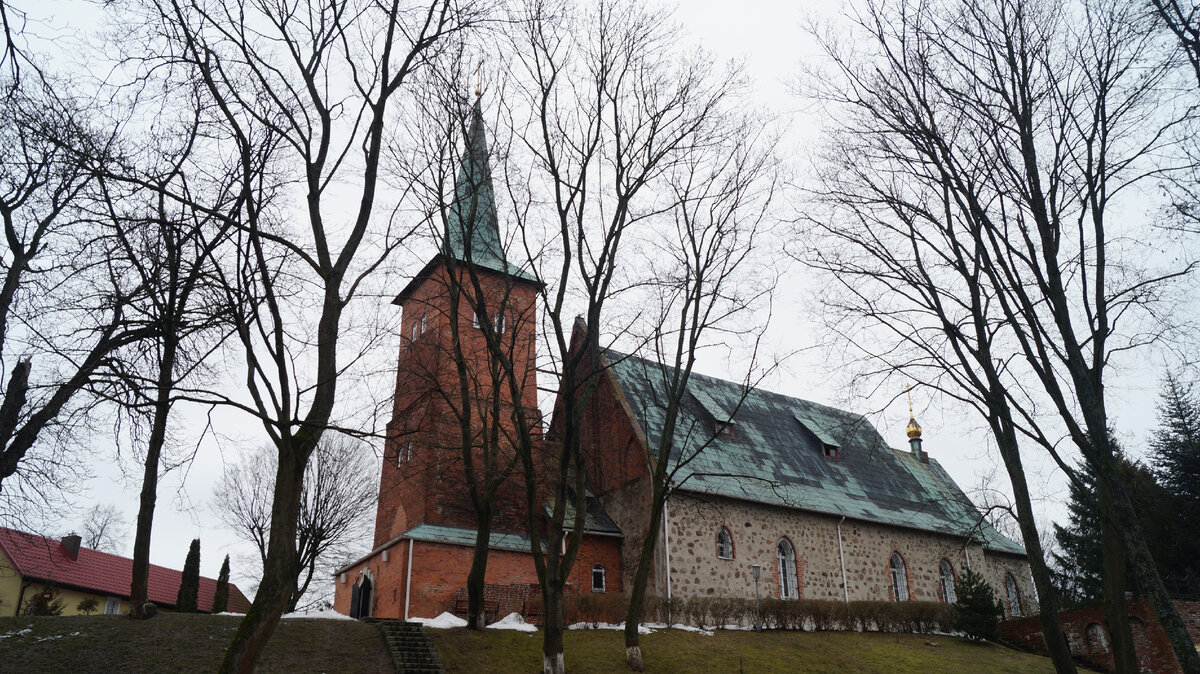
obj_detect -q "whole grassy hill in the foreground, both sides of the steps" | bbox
[0,614,1052,674]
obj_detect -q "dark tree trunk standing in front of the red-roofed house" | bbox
[130,330,179,618]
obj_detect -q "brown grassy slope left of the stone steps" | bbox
[0,614,392,673]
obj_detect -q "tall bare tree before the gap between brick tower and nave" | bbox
[417,2,768,673]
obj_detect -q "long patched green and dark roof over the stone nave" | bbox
[606,351,1025,554]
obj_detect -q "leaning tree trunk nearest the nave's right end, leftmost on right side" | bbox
[994,413,1075,674]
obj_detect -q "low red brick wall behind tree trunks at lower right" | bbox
[1000,597,1200,673]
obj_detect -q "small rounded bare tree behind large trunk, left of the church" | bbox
[212,435,376,613]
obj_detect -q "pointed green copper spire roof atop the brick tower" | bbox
[443,98,538,282]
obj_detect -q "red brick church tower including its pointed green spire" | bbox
[374,98,539,546]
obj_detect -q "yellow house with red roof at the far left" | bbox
[0,528,250,615]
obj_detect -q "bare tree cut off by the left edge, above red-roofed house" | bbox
[0,61,148,525]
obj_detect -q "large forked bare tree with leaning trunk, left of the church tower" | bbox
[120,0,478,672]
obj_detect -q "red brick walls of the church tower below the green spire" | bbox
[374,265,538,546]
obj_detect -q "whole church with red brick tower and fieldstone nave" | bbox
[334,101,1037,620]
